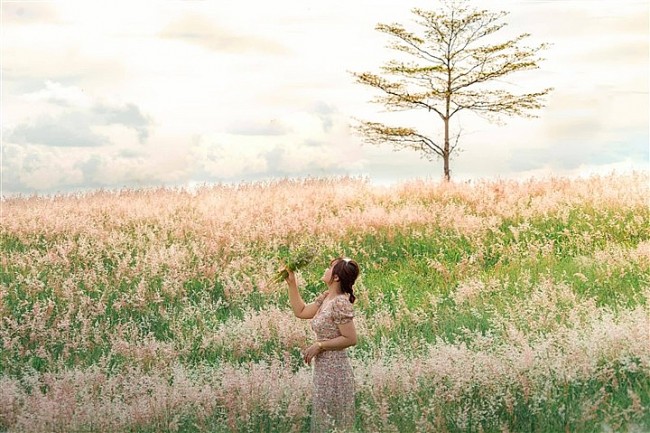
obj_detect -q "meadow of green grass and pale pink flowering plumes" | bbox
[0,173,650,433]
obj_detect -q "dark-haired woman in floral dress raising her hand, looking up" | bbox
[286,258,359,433]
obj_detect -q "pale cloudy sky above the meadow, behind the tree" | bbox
[1,0,649,197]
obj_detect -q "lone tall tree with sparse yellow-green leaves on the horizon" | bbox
[353,0,552,181]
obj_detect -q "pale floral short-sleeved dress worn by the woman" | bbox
[311,292,354,433]
